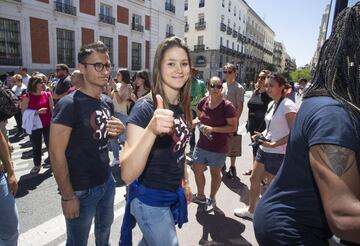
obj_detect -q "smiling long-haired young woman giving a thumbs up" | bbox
[120,36,192,246]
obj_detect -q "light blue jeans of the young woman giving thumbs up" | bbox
[130,198,179,246]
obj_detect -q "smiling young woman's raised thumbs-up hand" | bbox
[148,95,174,135]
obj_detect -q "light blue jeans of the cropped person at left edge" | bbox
[0,172,19,246]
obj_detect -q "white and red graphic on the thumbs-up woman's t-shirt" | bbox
[171,116,191,164]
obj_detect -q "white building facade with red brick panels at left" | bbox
[0,0,184,72]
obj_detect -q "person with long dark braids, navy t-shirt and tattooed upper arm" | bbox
[254,3,360,245]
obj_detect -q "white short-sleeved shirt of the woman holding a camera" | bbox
[260,97,298,154]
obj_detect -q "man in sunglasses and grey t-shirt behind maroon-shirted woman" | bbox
[222,63,245,178]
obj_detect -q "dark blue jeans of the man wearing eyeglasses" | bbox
[66,175,115,246]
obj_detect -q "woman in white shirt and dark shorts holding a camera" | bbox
[234,73,297,219]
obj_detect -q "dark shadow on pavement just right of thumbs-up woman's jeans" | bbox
[196,205,251,246]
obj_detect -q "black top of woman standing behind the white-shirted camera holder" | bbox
[247,91,272,132]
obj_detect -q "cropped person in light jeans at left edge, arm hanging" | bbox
[0,132,19,246]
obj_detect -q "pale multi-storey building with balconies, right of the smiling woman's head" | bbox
[185,0,275,84]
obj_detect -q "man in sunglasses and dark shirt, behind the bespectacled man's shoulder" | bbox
[52,64,71,105]
